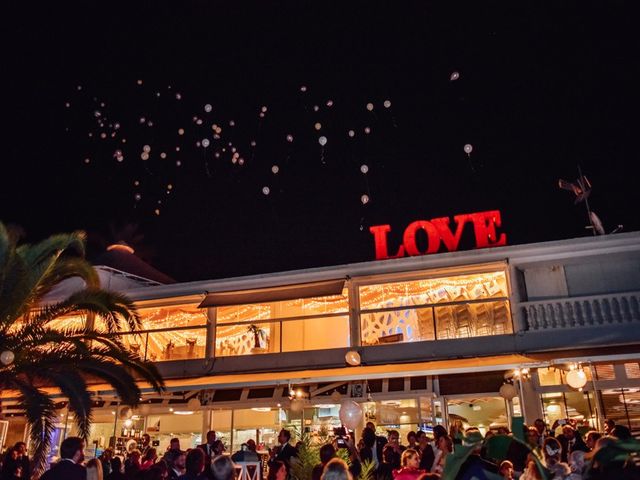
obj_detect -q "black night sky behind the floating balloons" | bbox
[0,1,640,280]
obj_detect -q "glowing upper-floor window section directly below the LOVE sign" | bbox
[360,271,513,345]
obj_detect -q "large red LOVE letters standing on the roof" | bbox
[369,210,507,260]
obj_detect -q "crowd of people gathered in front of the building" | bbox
[0,419,640,480]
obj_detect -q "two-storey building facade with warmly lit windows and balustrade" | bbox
[2,233,640,458]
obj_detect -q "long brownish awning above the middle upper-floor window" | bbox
[198,278,345,308]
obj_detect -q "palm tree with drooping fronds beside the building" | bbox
[0,222,164,476]
